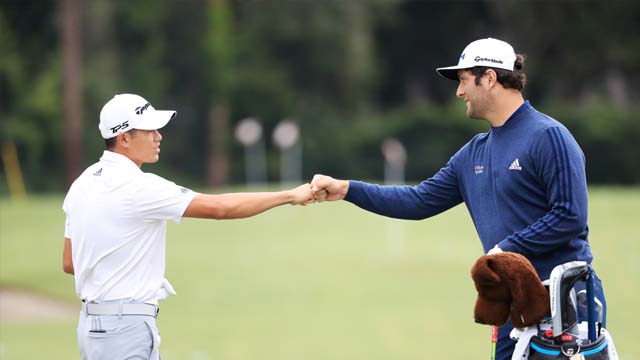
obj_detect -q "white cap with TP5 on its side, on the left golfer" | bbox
[98,94,176,139]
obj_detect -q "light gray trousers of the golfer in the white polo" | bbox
[78,309,160,360]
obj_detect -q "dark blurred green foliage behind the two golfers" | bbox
[0,0,640,192]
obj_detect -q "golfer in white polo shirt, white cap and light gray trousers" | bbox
[63,94,313,360]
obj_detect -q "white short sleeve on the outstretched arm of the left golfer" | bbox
[132,173,197,223]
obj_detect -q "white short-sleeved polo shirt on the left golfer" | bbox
[62,151,196,304]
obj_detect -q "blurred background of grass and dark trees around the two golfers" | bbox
[0,0,640,360]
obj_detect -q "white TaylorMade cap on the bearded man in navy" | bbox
[436,38,516,80]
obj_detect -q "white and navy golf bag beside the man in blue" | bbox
[511,261,618,360]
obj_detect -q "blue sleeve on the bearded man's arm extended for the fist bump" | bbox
[345,161,462,220]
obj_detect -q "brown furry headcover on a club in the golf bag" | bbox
[471,252,551,328]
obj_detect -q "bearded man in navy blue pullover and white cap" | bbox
[311,38,606,360]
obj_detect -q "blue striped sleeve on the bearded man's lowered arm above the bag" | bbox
[499,127,588,256]
